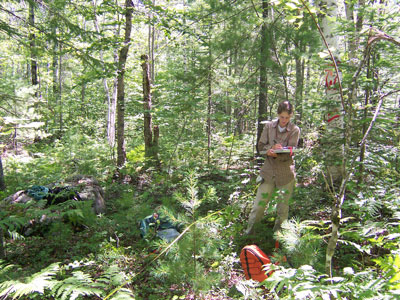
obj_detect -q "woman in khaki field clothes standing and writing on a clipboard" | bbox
[246,101,300,234]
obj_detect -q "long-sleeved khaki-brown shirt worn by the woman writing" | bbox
[258,120,300,187]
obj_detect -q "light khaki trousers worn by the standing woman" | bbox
[246,180,295,234]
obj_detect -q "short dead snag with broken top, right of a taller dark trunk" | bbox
[141,55,159,164]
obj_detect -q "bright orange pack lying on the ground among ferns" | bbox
[240,245,271,282]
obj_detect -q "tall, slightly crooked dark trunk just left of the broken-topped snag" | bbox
[117,0,133,167]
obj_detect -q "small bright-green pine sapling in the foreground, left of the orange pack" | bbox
[153,172,225,292]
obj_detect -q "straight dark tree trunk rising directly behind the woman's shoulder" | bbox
[256,0,269,156]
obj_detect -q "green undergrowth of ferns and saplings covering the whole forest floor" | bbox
[0,139,400,299]
